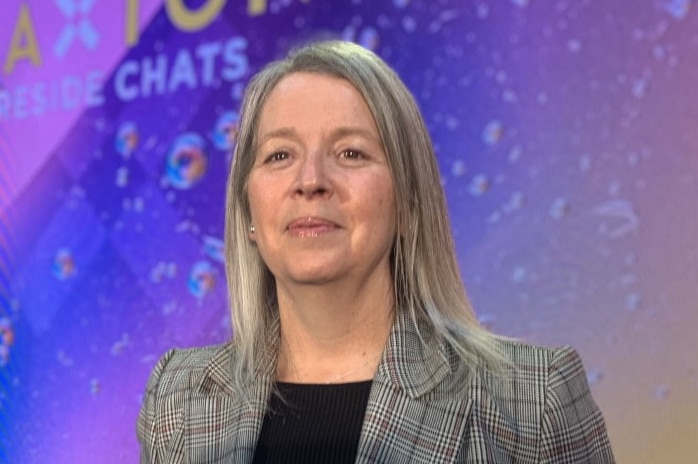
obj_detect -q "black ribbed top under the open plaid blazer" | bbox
[252,380,371,464]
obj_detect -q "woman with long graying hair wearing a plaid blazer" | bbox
[138,42,613,463]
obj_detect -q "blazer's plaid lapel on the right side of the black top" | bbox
[357,315,472,463]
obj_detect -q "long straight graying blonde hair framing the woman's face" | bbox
[225,41,502,393]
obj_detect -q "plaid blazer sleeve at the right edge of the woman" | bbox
[540,347,615,464]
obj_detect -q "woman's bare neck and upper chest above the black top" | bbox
[276,275,394,383]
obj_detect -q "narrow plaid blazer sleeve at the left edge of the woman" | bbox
[136,350,174,464]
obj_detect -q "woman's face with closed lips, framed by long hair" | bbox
[247,72,396,285]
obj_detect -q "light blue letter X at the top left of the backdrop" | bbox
[53,0,99,58]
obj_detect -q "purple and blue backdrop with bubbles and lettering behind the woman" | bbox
[0,0,698,463]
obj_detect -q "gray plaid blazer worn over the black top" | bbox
[137,310,614,464]
